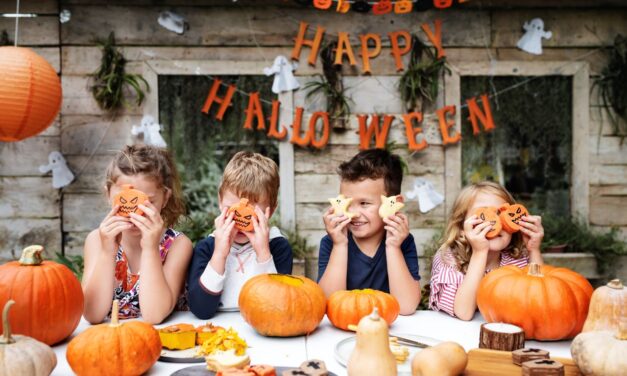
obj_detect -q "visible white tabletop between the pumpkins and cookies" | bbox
[52,311,571,375]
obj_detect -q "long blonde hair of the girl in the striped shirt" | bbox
[438,181,524,274]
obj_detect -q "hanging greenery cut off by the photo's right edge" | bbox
[595,35,627,144]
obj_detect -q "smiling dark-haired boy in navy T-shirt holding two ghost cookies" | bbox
[318,149,420,315]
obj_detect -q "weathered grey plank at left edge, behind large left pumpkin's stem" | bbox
[0,218,61,263]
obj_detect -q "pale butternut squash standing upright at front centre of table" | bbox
[347,307,397,376]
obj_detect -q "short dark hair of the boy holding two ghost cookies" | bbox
[337,149,403,196]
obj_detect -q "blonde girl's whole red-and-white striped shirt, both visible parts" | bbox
[429,250,529,316]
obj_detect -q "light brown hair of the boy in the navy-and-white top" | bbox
[219,151,280,208]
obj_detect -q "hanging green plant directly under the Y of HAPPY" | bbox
[398,36,449,111]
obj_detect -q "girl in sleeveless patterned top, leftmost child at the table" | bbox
[83,145,192,324]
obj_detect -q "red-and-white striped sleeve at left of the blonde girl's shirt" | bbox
[429,252,464,316]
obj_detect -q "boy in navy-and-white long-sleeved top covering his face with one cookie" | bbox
[188,152,292,319]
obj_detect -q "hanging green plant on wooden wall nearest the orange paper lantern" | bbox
[91,32,150,110]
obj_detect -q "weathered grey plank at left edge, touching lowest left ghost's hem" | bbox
[0,176,61,218]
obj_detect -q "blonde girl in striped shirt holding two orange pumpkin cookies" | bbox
[429,181,544,320]
